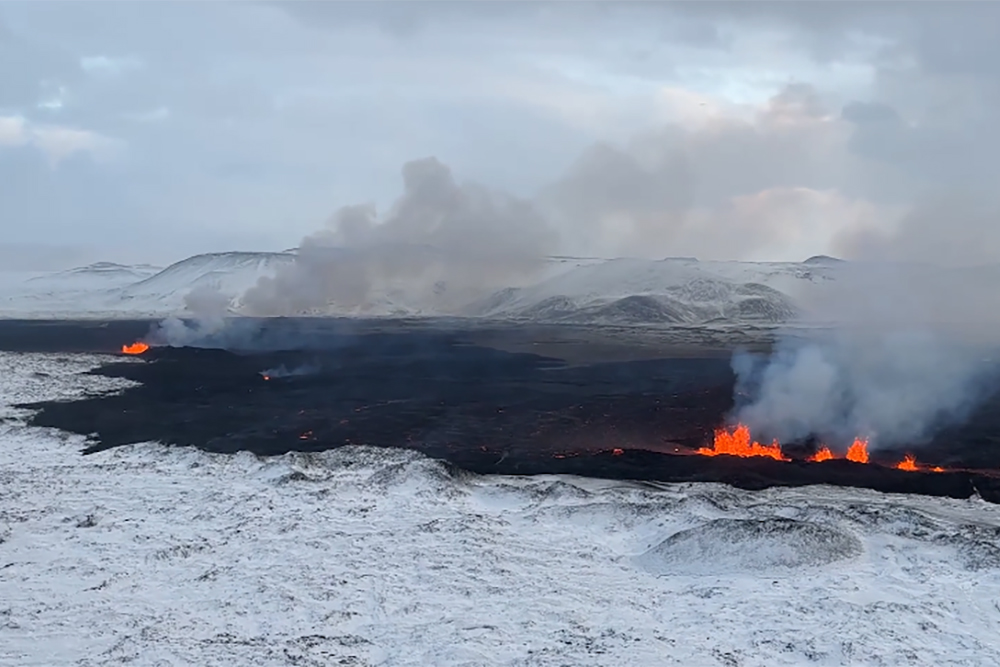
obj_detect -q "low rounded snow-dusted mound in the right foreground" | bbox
[637,518,861,575]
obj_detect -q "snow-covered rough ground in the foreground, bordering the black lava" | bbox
[0,354,1000,667]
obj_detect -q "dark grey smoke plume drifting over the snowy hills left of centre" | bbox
[242,158,558,316]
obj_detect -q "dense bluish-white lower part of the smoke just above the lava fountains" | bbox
[733,328,984,447]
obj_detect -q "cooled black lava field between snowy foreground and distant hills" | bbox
[9,318,1000,501]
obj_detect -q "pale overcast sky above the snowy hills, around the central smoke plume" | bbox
[0,1,1000,267]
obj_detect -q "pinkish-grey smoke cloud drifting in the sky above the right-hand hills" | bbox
[539,85,880,259]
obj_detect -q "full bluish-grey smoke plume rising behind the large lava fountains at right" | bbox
[732,262,997,448]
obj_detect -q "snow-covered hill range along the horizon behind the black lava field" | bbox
[0,247,1000,325]
